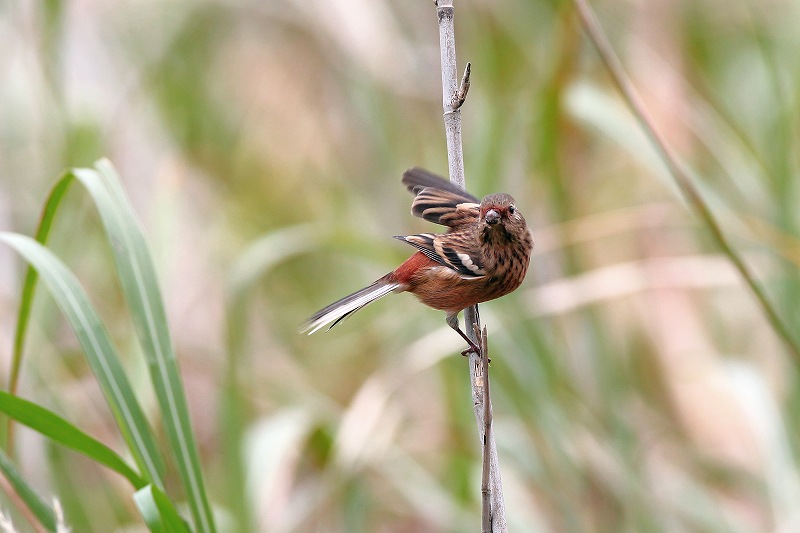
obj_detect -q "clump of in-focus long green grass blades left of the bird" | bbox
[0,161,215,531]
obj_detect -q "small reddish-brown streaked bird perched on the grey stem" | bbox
[301,167,533,353]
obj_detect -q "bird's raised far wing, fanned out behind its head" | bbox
[402,167,480,229]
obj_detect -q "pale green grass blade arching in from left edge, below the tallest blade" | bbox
[0,233,164,485]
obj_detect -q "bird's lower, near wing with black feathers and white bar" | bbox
[395,233,486,278]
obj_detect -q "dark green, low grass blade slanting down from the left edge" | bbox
[0,391,147,489]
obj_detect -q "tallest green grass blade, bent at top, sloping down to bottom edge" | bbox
[86,160,216,533]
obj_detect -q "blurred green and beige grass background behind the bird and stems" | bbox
[0,0,800,532]
